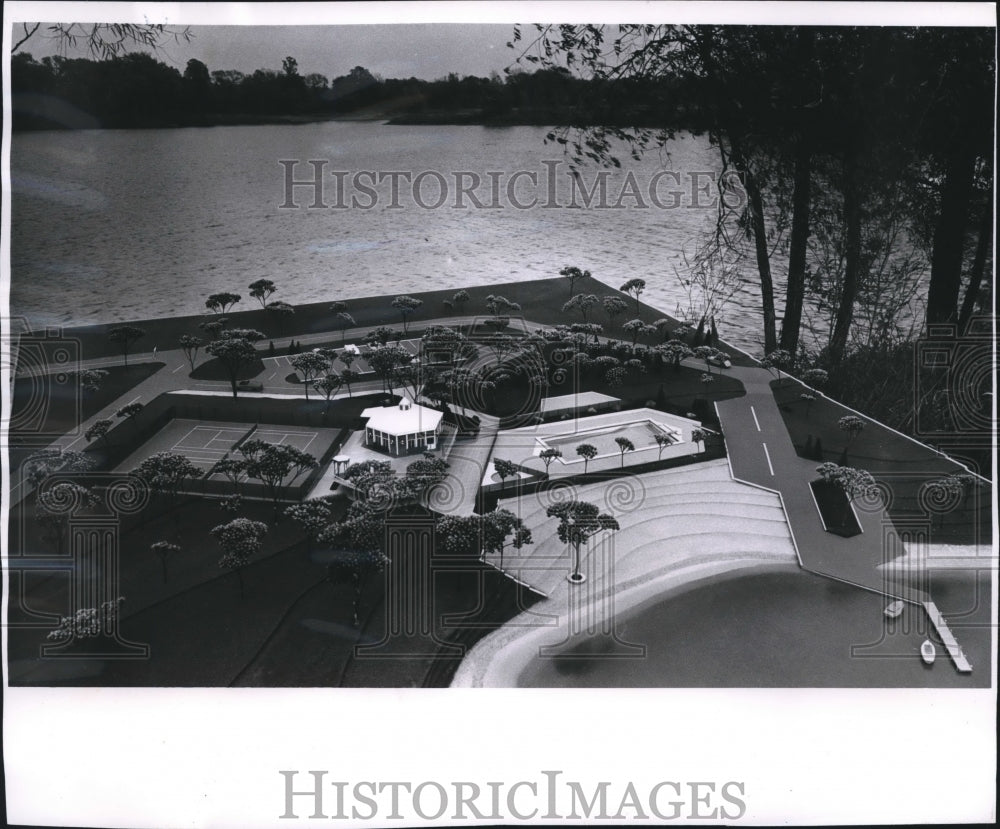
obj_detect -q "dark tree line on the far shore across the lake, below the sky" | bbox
[11,52,694,130]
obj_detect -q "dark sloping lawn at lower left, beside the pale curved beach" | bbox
[9,488,532,687]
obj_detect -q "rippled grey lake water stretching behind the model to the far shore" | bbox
[11,122,804,351]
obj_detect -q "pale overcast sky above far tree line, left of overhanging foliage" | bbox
[22,23,516,80]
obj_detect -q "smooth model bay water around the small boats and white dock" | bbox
[518,571,992,688]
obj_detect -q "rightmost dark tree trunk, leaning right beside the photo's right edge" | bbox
[927,141,976,325]
